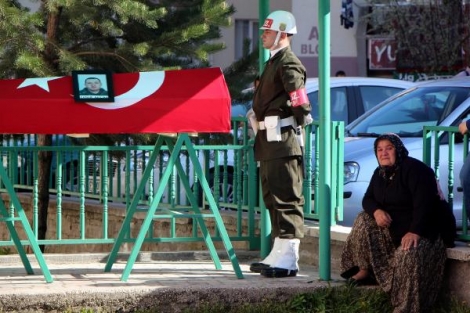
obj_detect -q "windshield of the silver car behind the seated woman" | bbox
[349,87,468,137]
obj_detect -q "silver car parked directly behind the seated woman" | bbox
[339,77,470,226]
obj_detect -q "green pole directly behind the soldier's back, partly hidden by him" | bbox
[259,0,271,258]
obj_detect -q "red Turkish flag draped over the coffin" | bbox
[0,68,231,134]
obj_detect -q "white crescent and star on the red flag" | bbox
[18,71,165,110]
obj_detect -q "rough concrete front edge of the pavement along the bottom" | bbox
[0,284,327,313]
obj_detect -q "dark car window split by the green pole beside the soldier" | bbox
[308,87,348,123]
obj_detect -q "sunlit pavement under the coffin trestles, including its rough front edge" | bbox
[0,252,342,312]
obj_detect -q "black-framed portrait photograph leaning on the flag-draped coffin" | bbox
[72,70,114,102]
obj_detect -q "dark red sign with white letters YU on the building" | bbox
[369,38,397,70]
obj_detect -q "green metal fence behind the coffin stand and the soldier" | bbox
[0,117,344,249]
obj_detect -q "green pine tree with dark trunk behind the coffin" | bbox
[0,0,234,246]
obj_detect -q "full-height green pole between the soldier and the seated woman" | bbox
[318,0,331,280]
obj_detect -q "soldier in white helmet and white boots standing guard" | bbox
[248,11,310,277]
